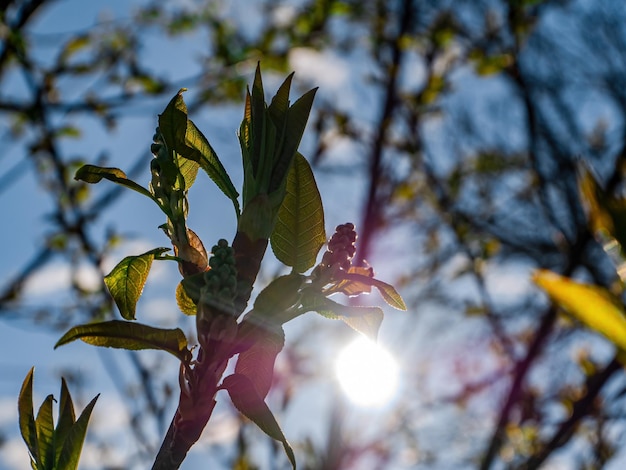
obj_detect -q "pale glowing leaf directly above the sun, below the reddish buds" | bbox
[302,293,384,341]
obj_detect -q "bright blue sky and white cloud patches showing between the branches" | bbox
[0,0,618,470]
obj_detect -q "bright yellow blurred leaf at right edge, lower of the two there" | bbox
[533,270,626,351]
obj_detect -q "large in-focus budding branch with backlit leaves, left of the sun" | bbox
[56,67,406,468]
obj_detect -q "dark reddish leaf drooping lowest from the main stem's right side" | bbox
[222,374,296,470]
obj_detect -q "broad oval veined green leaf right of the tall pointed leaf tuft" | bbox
[270,153,326,273]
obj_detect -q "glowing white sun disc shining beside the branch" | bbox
[335,337,398,407]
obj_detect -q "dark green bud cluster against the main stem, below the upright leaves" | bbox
[202,239,237,302]
